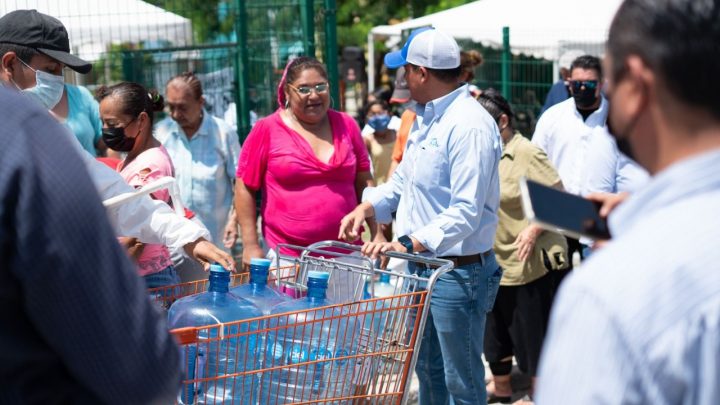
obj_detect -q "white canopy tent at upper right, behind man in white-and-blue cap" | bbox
[368,0,622,91]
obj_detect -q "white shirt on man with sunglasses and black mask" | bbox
[532,97,616,195]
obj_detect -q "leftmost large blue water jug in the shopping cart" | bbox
[168,265,262,404]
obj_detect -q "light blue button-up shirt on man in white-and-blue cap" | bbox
[363,85,502,256]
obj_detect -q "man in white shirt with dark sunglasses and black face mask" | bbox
[532,55,617,272]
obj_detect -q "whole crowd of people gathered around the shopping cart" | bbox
[0,0,720,405]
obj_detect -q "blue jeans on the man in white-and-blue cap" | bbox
[410,254,502,405]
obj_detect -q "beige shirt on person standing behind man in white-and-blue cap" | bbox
[494,133,568,286]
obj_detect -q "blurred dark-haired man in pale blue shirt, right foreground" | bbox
[536,0,720,405]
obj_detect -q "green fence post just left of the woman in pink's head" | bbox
[235,0,250,144]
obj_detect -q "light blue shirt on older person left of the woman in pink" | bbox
[155,111,240,246]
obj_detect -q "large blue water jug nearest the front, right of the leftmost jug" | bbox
[260,271,360,404]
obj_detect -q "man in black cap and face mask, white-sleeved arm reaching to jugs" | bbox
[0,10,235,268]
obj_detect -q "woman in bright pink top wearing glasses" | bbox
[235,57,376,266]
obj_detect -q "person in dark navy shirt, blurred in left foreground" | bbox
[0,86,181,404]
